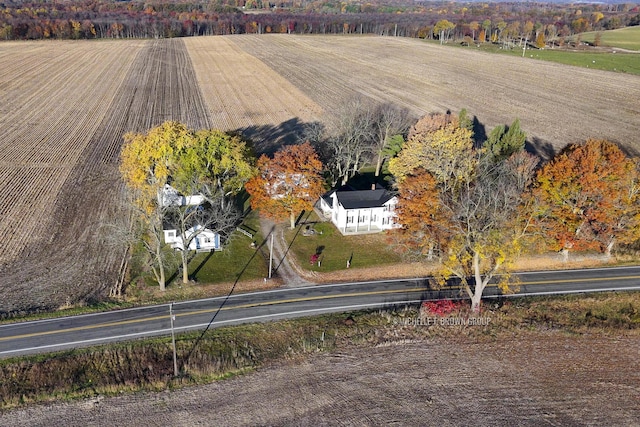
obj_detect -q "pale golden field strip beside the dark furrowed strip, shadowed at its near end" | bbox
[185,37,322,152]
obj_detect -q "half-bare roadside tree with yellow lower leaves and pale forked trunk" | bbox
[437,151,538,312]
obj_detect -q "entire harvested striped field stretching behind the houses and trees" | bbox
[0,35,640,314]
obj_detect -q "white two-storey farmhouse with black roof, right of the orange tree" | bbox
[320,187,400,234]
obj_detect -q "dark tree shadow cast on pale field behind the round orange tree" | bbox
[234,117,319,155]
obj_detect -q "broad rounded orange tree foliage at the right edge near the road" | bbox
[532,140,640,259]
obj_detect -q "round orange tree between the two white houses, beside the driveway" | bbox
[245,142,324,228]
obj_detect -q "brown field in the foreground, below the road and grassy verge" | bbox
[0,331,640,427]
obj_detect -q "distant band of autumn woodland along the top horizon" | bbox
[0,0,640,42]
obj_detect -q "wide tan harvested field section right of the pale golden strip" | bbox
[233,34,640,154]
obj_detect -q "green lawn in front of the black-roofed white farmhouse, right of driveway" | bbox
[285,212,401,272]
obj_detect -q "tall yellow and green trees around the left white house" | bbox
[120,121,255,290]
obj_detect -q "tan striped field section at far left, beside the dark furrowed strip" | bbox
[0,42,144,276]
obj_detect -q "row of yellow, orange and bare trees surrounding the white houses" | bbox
[121,105,640,310]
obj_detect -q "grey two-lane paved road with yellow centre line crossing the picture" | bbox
[0,266,640,358]
